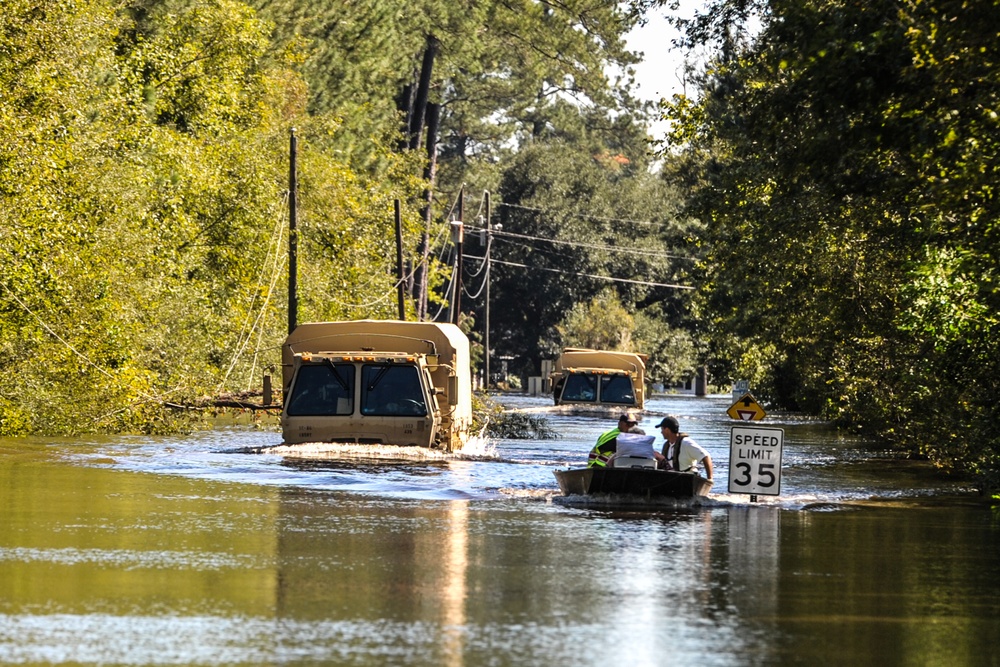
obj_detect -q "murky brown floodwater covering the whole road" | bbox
[0,396,1000,667]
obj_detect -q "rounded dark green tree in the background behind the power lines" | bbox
[491,134,691,375]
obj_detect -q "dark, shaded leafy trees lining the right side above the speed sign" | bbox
[669,0,1000,486]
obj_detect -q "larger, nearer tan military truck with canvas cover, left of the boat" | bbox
[281,320,472,451]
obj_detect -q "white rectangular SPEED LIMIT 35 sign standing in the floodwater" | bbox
[729,426,785,500]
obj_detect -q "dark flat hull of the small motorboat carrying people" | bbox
[554,466,712,498]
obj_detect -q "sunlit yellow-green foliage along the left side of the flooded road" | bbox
[0,0,419,434]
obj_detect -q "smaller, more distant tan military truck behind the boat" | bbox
[549,347,648,410]
